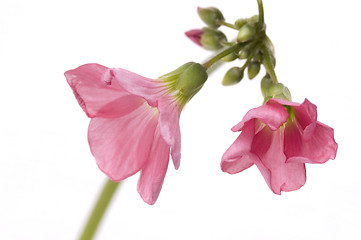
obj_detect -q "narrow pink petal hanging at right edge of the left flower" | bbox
[158,97,181,169]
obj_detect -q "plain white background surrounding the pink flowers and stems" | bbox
[0,0,361,240]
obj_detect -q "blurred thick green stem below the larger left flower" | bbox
[79,179,119,240]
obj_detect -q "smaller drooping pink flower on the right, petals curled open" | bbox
[221,99,337,194]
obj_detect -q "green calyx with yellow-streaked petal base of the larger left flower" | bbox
[159,62,208,107]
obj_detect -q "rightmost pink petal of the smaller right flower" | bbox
[288,122,338,163]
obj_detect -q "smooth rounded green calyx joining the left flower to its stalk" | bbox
[175,62,208,97]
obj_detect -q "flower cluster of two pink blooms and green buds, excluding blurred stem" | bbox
[65,0,337,204]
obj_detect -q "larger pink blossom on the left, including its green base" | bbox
[65,63,207,204]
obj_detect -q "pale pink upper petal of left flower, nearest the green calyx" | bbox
[111,68,166,107]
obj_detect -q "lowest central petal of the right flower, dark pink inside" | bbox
[252,128,306,194]
